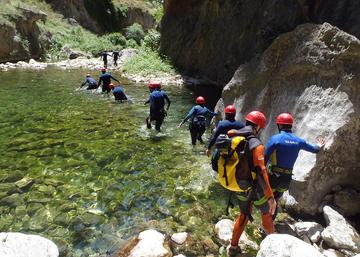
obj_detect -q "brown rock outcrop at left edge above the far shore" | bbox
[0,7,49,62]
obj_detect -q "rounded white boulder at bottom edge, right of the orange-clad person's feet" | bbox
[256,234,324,257]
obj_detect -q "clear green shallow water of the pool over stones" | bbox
[0,69,226,256]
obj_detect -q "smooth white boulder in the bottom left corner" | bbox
[0,233,59,257]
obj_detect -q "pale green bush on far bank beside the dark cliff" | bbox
[123,47,176,75]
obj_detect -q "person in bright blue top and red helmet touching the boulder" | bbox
[265,113,325,220]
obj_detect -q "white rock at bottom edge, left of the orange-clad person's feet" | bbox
[129,229,171,257]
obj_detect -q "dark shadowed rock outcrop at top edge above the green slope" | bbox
[46,0,155,34]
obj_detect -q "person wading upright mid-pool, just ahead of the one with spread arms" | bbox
[145,82,171,132]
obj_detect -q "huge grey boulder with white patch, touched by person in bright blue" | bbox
[222,23,360,215]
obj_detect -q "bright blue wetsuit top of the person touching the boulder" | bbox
[265,130,320,170]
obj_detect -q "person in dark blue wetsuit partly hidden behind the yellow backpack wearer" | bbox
[206,105,244,157]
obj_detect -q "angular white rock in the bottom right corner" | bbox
[321,206,360,253]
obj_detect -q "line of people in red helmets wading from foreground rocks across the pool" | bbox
[82,68,325,254]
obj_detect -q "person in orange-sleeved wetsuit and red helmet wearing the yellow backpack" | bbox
[225,111,276,257]
